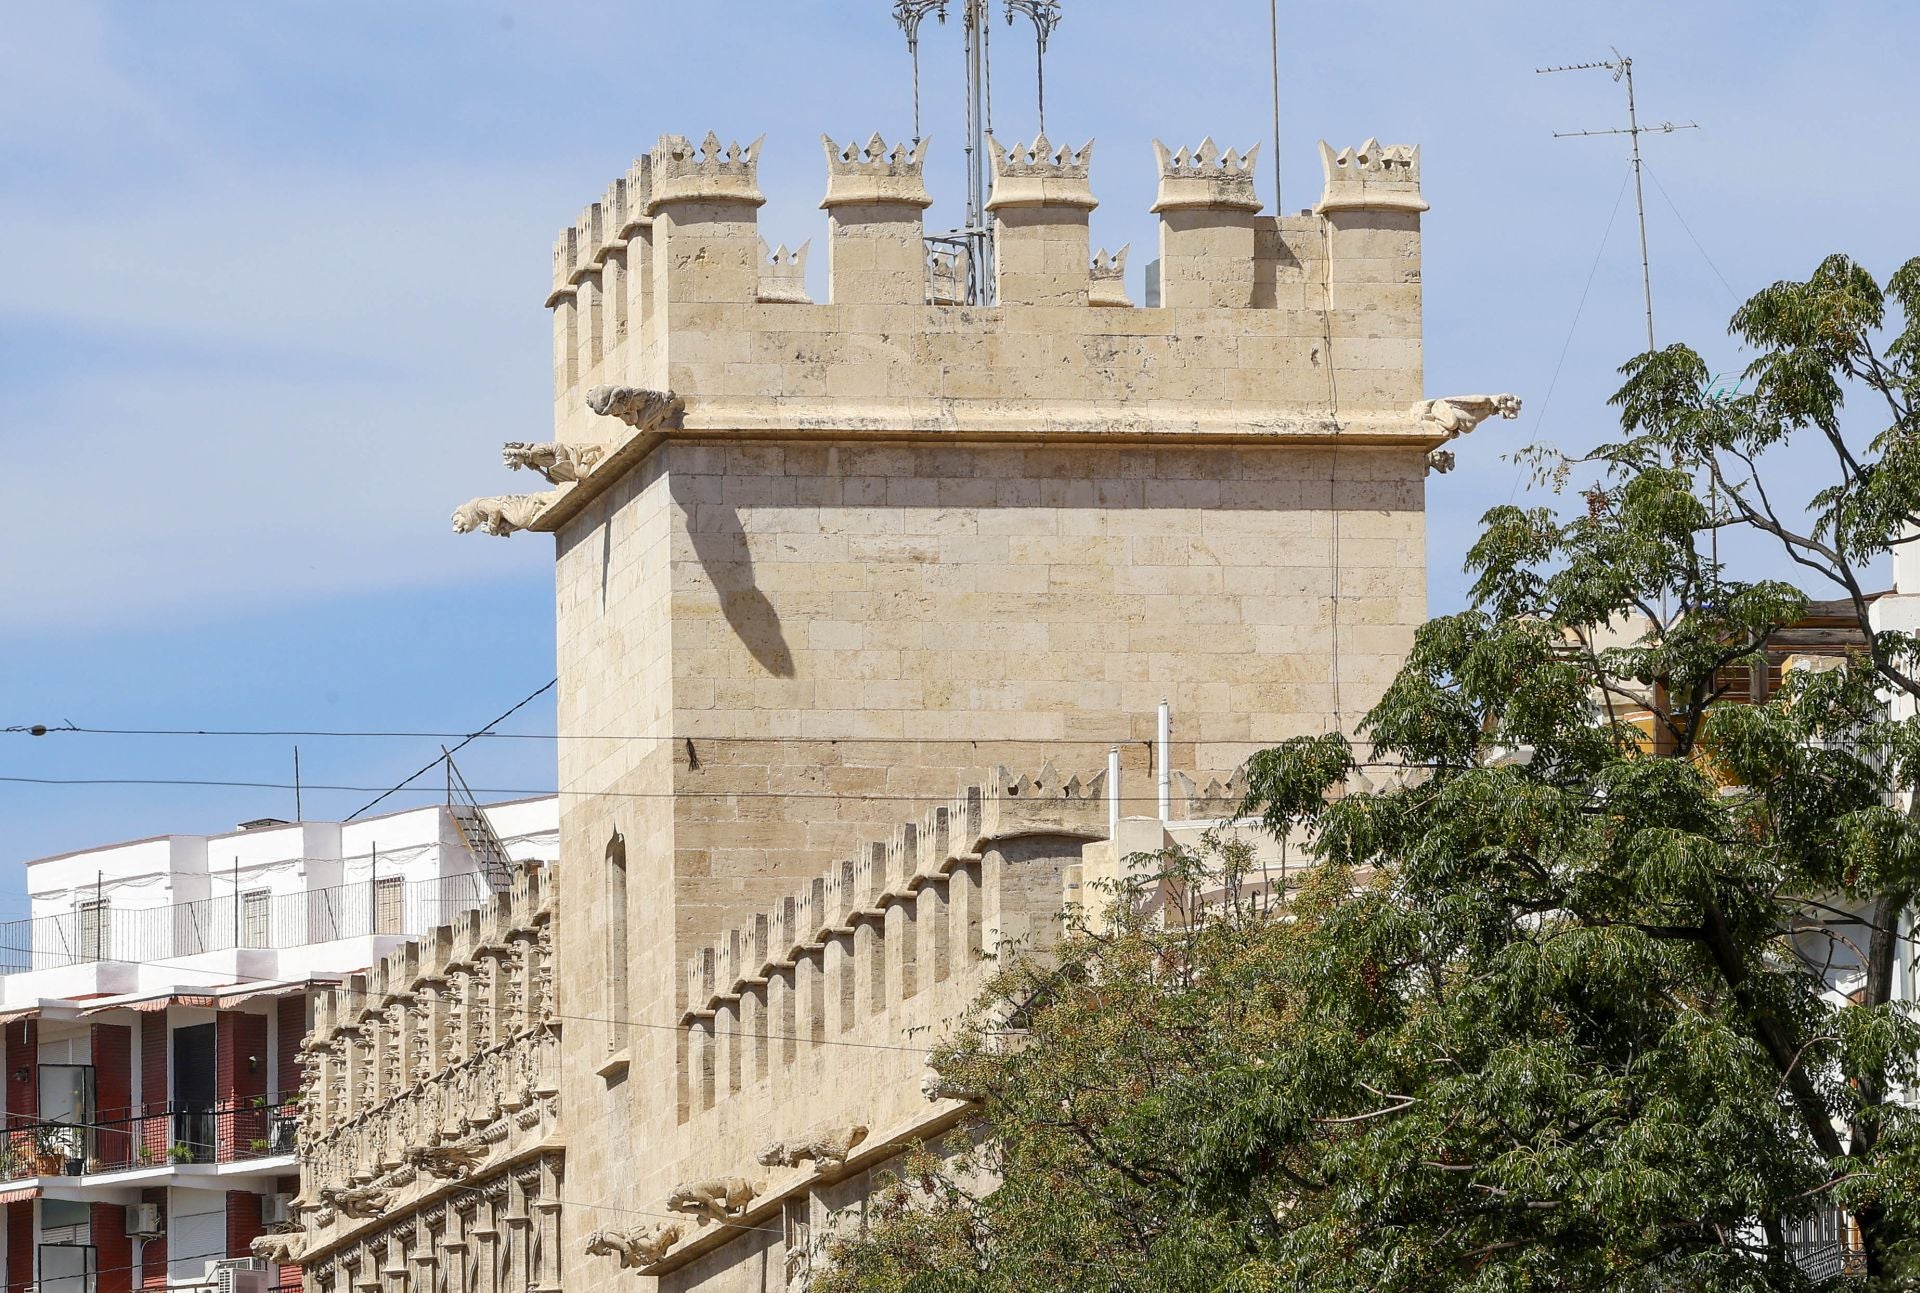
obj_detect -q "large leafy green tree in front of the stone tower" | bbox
[816,257,1920,1293]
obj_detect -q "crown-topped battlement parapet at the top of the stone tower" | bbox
[510,134,1430,530]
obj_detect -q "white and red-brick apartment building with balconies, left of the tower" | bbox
[0,797,559,1293]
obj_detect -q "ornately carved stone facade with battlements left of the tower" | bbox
[284,865,564,1293]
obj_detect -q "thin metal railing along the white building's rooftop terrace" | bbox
[0,872,492,972]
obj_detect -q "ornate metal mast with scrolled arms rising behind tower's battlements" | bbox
[893,0,1060,305]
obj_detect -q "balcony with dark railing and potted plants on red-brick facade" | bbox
[0,1101,300,1182]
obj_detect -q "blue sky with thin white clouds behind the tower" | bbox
[0,0,1920,906]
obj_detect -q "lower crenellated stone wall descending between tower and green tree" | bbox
[564,765,1108,1289]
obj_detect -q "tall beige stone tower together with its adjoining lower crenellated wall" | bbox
[455,128,1503,1289]
